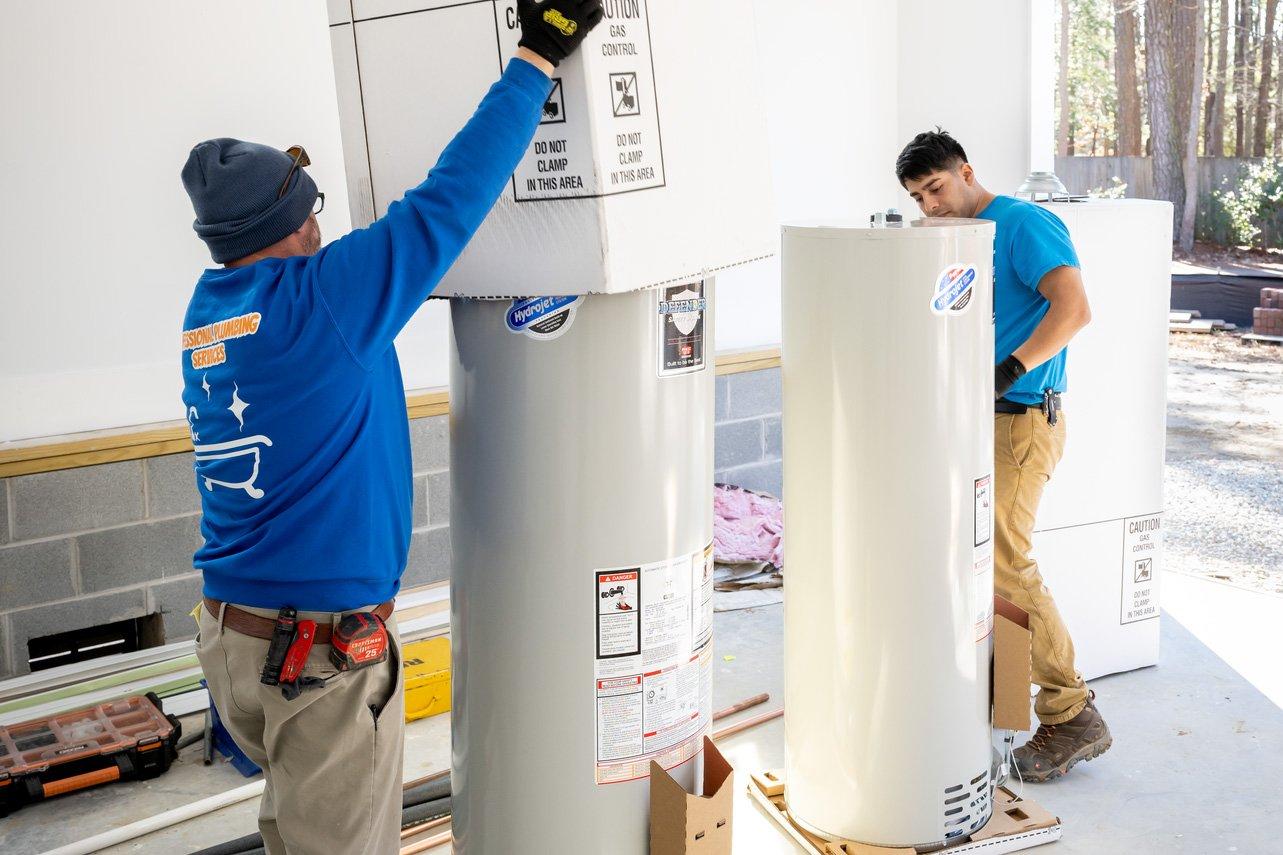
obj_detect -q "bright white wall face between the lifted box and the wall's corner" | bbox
[717,0,899,350]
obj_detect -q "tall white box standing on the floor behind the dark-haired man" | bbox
[1033,199,1171,679]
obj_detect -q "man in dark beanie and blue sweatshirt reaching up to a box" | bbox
[182,0,603,855]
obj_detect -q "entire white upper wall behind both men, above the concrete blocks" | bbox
[0,0,1052,442]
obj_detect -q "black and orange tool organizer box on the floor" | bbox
[0,692,182,816]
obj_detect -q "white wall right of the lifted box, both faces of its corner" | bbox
[717,0,1041,349]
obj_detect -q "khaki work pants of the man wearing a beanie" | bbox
[196,606,405,855]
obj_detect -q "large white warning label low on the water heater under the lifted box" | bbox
[594,544,712,784]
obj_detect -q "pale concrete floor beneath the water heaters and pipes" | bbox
[0,593,1283,855]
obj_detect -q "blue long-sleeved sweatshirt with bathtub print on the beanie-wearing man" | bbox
[182,59,552,611]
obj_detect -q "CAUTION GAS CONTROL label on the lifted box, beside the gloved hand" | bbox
[495,0,665,202]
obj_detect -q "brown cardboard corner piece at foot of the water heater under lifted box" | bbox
[650,737,735,855]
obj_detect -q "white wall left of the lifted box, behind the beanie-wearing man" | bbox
[0,0,349,442]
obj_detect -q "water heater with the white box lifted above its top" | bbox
[450,282,715,855]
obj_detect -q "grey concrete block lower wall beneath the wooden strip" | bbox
[0,368,783,678]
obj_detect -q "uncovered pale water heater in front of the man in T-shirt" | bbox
[783,220,994,846]
